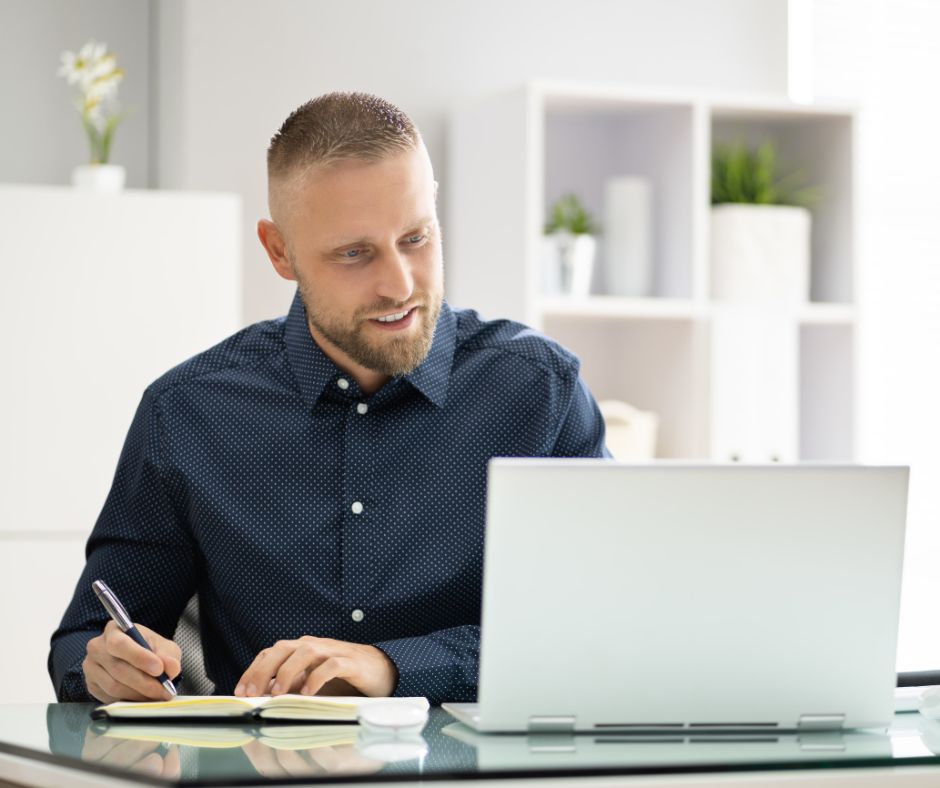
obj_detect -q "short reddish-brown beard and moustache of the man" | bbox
[295,270,444,377]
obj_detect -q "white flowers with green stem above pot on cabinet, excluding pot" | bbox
[57,41,124,164]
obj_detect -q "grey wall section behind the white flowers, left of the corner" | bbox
[0,0,150,187]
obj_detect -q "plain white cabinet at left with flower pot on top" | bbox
[0,185,241,701]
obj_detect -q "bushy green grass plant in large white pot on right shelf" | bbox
[711,141,816,303]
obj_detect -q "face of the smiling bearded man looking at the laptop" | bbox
[279,151,444,376]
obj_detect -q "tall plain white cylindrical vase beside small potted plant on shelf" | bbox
[603,175,653,298]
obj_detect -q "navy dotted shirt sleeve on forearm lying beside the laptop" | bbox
[374,625,480,704]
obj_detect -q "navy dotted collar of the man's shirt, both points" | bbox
[284,290,457,408]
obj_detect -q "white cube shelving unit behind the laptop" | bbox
[445,83,857,462]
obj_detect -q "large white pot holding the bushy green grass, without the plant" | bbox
[711,204,810,304]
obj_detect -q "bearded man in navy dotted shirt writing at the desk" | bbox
[49,94,604,702]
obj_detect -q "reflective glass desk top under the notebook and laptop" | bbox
[0,703,940,785]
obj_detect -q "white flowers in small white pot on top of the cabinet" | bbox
[58,41,125,192]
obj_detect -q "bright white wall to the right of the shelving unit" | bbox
[805,0,940,670]
